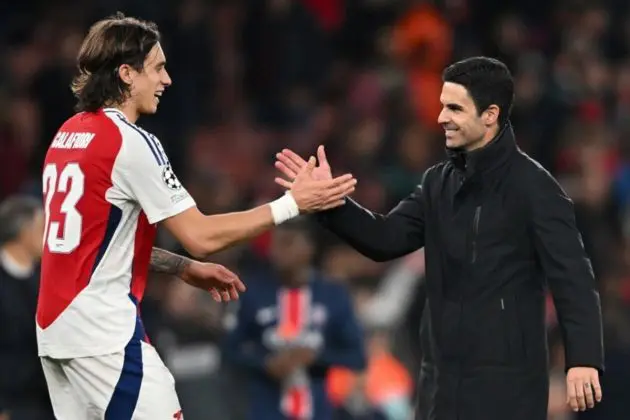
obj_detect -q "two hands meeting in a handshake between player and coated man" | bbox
[275,146,357,217]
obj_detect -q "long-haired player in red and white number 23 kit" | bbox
[36,14,356,420]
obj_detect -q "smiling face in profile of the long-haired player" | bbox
[130,43,172,114]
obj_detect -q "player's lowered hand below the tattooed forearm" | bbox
[181,261,246,302]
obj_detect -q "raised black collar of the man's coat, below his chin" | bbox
[446,122,517,178]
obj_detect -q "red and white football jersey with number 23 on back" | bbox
[37,108,195,358]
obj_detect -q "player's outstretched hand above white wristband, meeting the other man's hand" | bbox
[286,150,357,213]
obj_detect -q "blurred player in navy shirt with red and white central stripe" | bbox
[224,219,366,420]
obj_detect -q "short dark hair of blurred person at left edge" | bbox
[0,195,42,245]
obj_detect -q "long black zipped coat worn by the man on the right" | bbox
[318,125,604,420]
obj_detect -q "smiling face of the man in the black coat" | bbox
[438,82,489,150]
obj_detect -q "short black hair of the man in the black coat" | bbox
[442,57,514,125]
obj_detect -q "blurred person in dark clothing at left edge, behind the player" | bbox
[0,195,55,420]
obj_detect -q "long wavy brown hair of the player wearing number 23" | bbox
[71,12,160,112]
